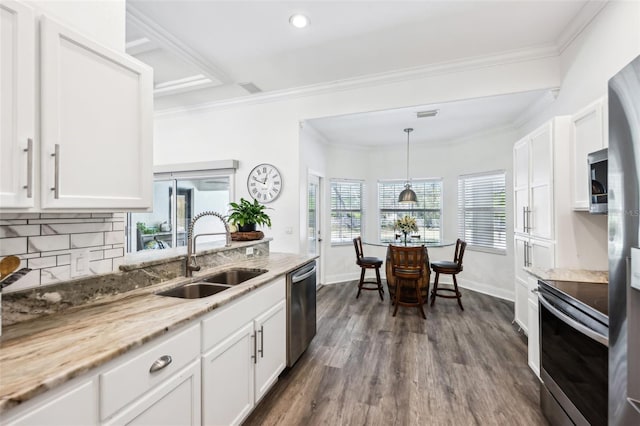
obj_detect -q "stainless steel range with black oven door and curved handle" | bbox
[538,280,609,425]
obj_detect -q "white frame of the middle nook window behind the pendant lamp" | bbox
[377,177,444,245]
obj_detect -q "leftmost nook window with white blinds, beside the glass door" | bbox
[331,180,364,244]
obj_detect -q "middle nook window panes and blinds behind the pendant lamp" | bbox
[378,179,442,243]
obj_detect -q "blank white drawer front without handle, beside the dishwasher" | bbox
[202,277,286,353]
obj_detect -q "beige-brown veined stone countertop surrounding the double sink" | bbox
[0,253,317,414]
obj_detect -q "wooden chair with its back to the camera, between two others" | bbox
[389,245,427,319]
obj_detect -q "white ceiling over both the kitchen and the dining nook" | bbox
[126,0,605,146]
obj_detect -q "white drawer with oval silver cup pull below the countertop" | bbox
[100,325,200,420]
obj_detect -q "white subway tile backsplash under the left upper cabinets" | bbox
[0,213,126,293]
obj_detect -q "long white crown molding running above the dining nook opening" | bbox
[155,45,558,117]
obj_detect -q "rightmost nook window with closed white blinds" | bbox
[458,171,507,254]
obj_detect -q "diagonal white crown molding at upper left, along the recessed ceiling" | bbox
[126,2,233,84]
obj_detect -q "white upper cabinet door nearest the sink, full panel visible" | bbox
[40,18,153,210]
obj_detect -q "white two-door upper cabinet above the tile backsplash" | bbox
[0,5,153,212]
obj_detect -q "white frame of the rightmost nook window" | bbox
[458,169,508,256]
